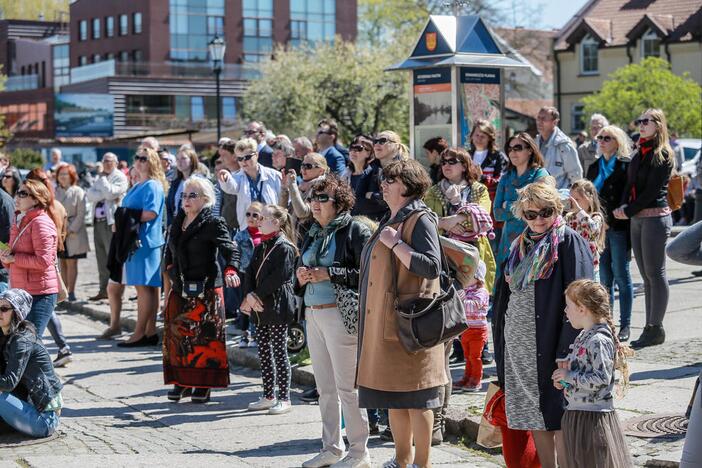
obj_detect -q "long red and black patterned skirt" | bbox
[163,288,229,388]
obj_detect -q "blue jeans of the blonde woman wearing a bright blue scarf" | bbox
[600,229,634,329]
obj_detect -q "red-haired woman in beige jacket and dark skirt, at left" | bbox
[56,164,90,301]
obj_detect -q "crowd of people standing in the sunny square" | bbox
[0,107,699,468]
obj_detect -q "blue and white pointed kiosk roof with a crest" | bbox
[389,15,528,70]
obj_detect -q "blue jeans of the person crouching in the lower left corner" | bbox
[0,392,59,437]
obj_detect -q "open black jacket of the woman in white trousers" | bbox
[295,219,371,310]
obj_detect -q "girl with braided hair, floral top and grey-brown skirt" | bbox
[551,279,632,468]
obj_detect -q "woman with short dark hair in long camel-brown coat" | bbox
[356,160,448,468]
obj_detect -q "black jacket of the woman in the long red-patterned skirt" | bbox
[164,208,240,293]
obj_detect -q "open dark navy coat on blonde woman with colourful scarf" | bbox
[492,227,594,431]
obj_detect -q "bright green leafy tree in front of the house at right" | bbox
[581,57,702,138]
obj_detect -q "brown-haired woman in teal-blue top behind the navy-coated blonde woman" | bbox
[493,132,548,281]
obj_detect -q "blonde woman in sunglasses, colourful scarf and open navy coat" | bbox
[493,180,594,468]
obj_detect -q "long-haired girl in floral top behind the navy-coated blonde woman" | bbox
[565,179,606,279]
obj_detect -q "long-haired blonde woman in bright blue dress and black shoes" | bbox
[118,148,168,347]
